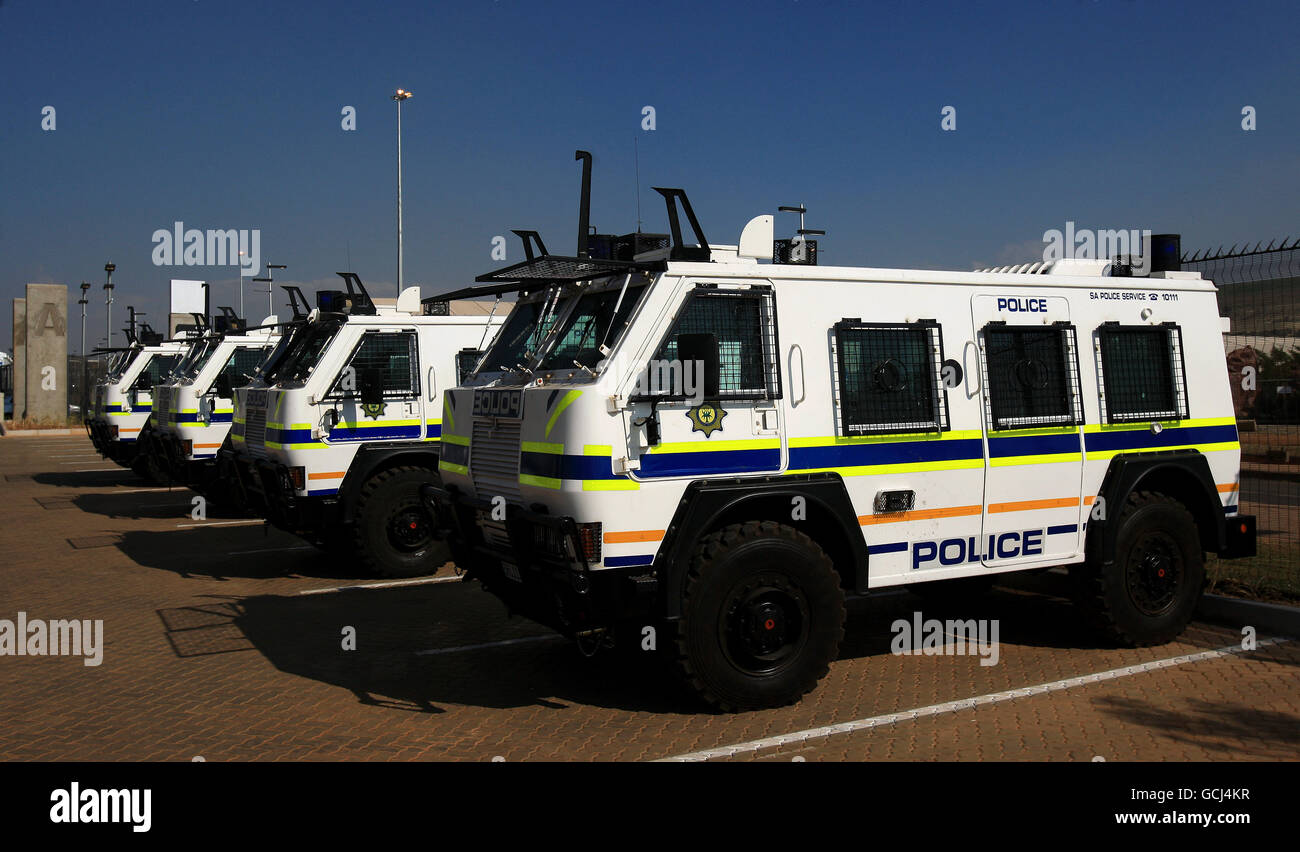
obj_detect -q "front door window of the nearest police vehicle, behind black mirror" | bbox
[642,284,781,401]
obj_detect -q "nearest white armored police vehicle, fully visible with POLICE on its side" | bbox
[423,152,1255,710]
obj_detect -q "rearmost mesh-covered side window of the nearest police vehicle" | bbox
[1097,323,1188,423]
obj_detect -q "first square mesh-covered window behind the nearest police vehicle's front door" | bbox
[835,320,948,436]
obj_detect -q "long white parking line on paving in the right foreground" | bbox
[655,636,1294,764]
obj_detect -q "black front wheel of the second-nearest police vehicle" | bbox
[352,467,451,578]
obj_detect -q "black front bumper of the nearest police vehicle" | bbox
[420,485,658,636]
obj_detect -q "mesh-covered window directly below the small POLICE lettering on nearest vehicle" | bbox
[982,323,1083,429]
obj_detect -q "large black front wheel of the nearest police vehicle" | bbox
[676,520,844,712]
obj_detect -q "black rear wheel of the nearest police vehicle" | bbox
[1071,492,1205,645]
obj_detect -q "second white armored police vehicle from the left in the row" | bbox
[140,307,281,501]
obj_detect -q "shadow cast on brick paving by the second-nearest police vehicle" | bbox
[117,530,374,581]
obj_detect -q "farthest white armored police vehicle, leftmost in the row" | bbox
[86,324,191,475]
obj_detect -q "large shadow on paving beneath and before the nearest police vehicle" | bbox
[220,581,1118,715]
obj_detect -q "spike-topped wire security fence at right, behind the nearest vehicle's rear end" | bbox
[1183,238,1300,600]
